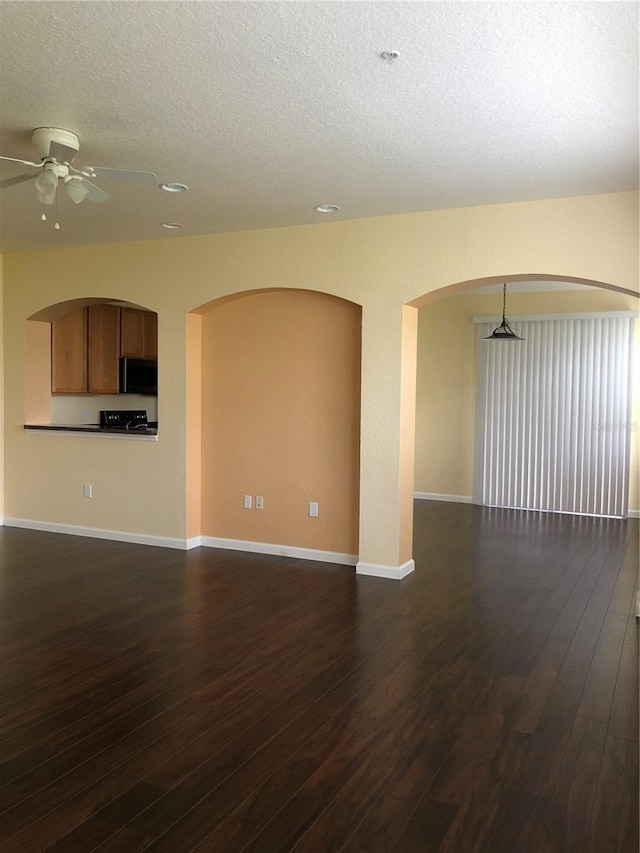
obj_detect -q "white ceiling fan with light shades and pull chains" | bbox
[0,127,158,220]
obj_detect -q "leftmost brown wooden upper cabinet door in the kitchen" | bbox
[51,308,87,394]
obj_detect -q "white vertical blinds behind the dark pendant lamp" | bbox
[474,317,634,516]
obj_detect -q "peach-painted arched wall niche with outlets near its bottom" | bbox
[187,289,361,564]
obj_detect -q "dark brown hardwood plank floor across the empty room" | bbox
[0,502,638,853]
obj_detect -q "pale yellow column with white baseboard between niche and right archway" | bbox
[356,303,418,580]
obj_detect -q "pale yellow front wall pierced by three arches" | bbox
[4,193,638,566]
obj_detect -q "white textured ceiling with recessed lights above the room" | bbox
[0,0,638,251]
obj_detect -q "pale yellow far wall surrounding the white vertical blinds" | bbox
[415,288,640,510]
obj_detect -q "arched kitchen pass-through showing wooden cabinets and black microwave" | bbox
[24,298,158,427]
